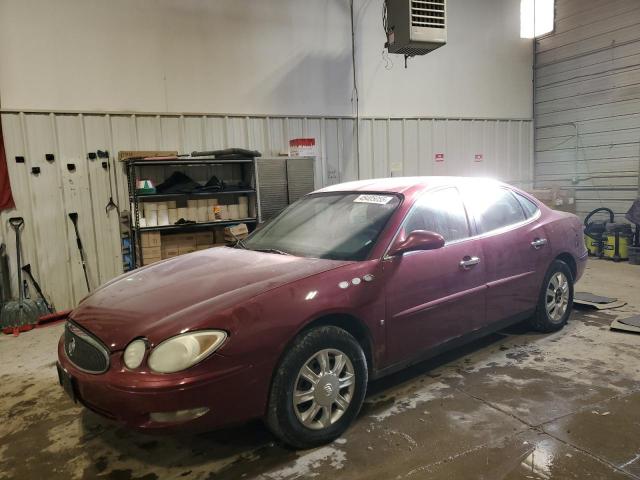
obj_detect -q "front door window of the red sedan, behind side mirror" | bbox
[403,187,470,243]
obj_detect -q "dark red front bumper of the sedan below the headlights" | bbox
[58,334,270,432]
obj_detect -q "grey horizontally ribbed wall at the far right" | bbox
[534,0,640,219]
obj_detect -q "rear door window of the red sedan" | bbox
[467,186,525,233]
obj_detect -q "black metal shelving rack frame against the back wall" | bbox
[126,157,260,267]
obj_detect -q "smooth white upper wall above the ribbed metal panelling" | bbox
[0,0,532,119]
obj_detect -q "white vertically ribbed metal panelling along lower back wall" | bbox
[0,111,533,308]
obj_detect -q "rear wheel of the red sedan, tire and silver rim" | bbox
[530,260,573,333]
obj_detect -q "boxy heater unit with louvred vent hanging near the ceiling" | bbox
[384,0,447,57]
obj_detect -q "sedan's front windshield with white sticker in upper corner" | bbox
[243,192,400,260]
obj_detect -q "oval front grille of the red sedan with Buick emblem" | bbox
[64,322,109,374]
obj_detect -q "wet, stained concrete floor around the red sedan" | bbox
[0,261,640,480]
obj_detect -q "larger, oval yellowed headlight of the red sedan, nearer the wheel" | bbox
[148,330,227,373]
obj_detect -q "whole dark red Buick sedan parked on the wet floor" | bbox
[58,177,587,448]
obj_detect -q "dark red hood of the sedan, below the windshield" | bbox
[70,248,350,350]
